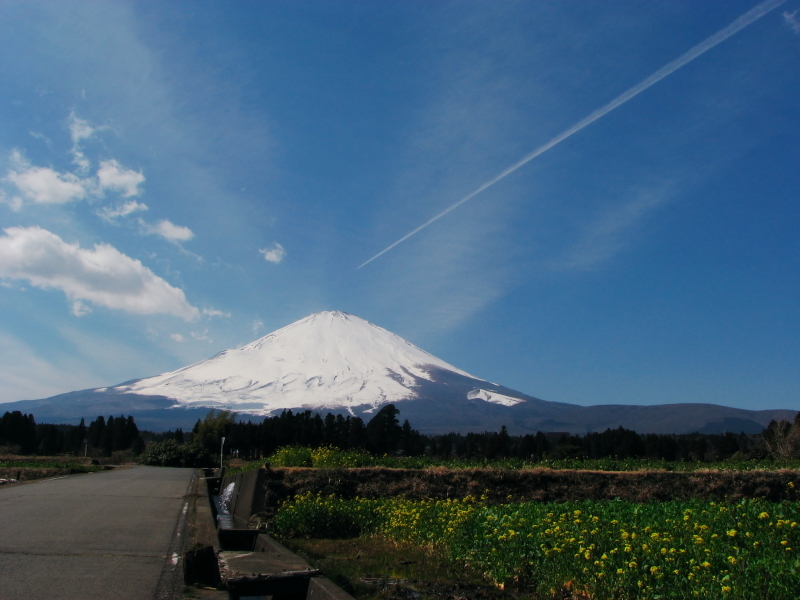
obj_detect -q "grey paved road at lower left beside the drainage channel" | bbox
[0,467,194,600]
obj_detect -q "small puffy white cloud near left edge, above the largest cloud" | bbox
[5,150,87,204]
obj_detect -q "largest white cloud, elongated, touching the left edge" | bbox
[0,227,200,320]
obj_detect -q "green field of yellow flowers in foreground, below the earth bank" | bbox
[273,484,800,600]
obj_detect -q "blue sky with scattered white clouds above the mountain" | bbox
[0,0,800,408]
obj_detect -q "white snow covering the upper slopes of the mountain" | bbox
[115,312,494,415]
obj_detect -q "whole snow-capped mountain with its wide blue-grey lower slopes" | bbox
[0,311,795,434]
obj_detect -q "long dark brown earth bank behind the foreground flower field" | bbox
[264,467,800,509]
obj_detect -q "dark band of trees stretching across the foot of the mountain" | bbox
[0,404,800,465]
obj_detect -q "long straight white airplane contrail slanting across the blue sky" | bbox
[356,0,786,270]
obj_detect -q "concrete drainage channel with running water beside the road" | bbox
[183,469,353,600]
